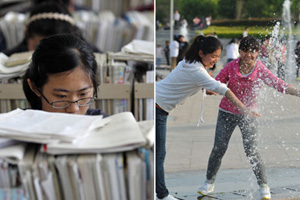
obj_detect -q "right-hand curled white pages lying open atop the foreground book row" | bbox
[47,112,147,154]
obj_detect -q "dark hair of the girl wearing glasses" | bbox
[23,34,98,110]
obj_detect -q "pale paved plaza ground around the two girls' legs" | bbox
[157,65,300,200]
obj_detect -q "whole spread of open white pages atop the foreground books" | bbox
[0,109,149,155]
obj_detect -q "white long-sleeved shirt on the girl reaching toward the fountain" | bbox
[156,59,228,112]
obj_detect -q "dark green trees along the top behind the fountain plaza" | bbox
[156,0,300,23]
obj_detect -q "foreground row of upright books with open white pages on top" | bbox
[0,110,154,200]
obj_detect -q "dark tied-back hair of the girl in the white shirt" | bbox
[185,35,222,63]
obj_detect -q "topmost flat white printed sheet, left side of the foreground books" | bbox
[0,110,103,136]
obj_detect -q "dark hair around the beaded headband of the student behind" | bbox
[26,1,78,38]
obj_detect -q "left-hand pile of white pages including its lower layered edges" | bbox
[0,109,109,144]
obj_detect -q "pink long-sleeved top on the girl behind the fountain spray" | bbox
[216,58,289,114]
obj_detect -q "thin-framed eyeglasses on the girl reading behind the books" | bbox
[39,91,95,109]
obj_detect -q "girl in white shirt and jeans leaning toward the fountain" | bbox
[155,35,259,200]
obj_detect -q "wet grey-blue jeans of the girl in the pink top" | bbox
[206,110,267,185]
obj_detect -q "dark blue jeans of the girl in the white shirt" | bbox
[155,107,169,199]
